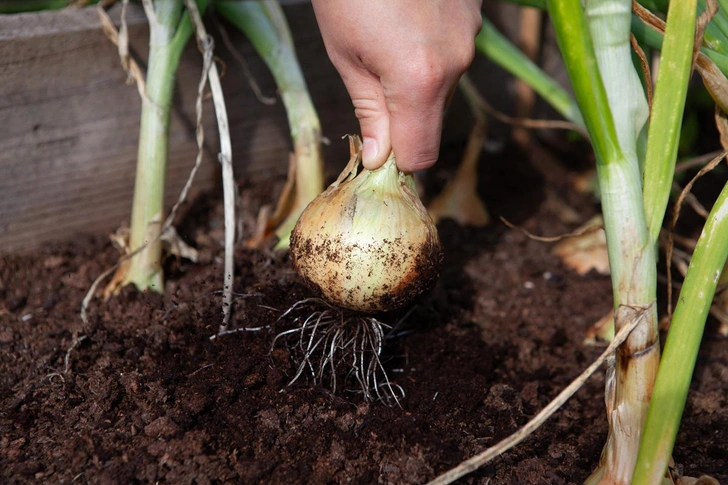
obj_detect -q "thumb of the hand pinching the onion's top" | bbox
[344,72,392,170]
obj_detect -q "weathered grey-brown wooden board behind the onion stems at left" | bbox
[0,4,357,252]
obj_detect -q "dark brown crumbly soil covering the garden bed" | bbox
[0,142,728,484]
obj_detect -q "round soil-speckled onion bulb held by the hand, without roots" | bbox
[291,137,442,312]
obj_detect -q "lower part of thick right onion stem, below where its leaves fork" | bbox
[587,164,659,485]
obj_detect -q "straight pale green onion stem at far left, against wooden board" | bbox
[124,0,191,292]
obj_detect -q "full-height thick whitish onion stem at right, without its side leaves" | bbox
[584,0,659,485]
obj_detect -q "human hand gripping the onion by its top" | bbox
[313,0,482,172]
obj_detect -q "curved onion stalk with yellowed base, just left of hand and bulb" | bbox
[215,0,324,248]
